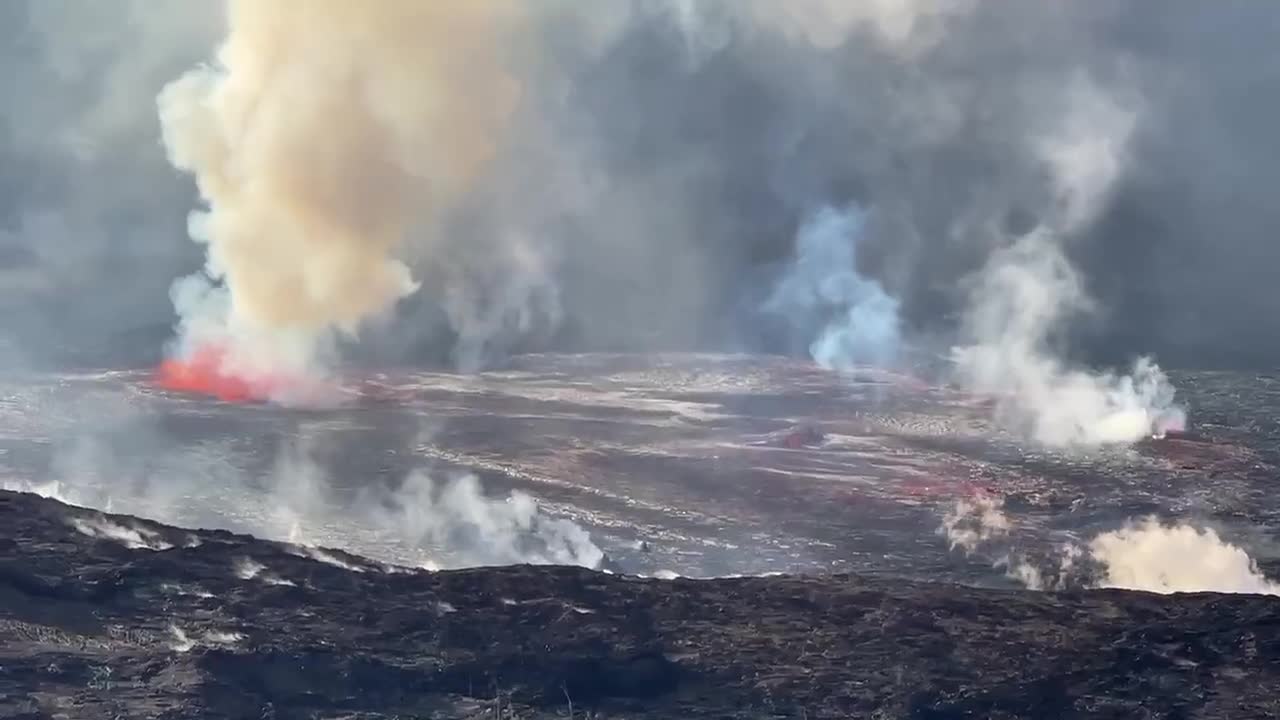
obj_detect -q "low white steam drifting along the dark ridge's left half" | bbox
[0,425,604,569]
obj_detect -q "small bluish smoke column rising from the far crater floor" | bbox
[764,208,900,370]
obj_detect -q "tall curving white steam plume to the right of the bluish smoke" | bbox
[952,77,1185,447]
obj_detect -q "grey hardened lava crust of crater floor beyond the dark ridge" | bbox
[0,355,1280,587]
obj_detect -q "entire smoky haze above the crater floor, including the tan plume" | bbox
[0,0,1280,415]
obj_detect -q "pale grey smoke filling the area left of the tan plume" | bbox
[0,0,221,366]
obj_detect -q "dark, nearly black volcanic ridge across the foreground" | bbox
[0,492,1280,720]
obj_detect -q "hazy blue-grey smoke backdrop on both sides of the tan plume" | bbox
[0,0,1280,381]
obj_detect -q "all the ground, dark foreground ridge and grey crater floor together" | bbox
[0,355,1280,717]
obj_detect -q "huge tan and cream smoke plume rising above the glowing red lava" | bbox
[159,0,520,396]
